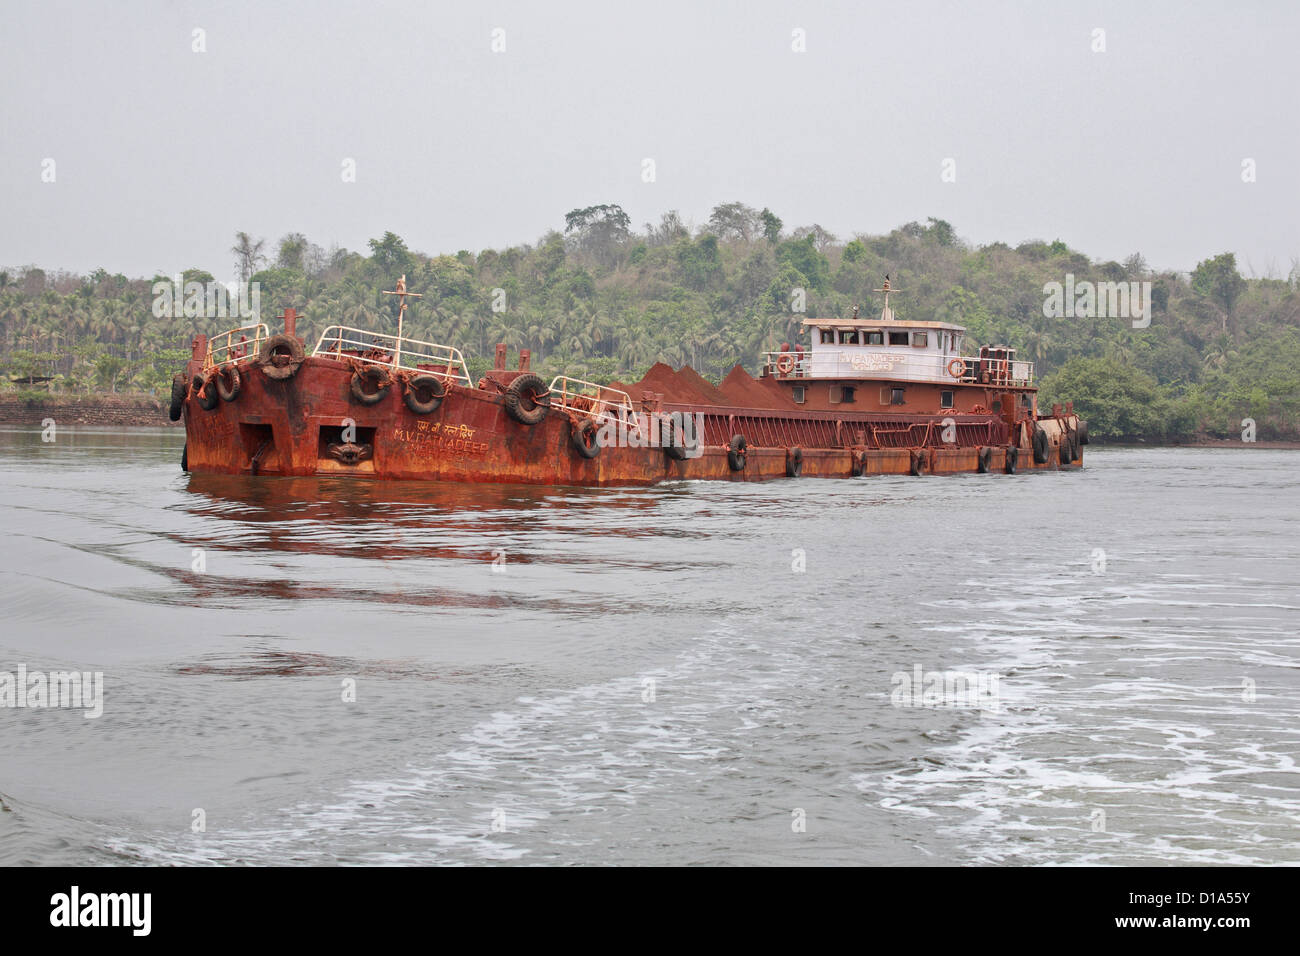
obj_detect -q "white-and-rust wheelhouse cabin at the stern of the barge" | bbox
[763,285,1037,420]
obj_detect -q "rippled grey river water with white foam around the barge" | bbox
[0,428,1300,865]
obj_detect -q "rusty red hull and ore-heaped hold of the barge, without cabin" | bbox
[183,329,1082,485]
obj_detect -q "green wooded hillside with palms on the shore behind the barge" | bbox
[0,202,1300,441]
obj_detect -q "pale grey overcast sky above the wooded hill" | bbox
[0,0,1300,278]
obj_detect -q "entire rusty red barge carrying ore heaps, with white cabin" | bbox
[169,278,1088,485]
